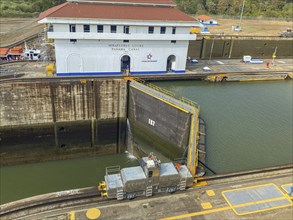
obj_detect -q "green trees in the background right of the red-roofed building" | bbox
[174,0,293,18]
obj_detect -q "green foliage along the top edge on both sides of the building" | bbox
[0,0,293,18]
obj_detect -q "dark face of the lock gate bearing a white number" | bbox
[128,86,191,159]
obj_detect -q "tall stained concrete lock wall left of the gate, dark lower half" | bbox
[0,79,127,165]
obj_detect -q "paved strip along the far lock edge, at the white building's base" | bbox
[0,59,293,79]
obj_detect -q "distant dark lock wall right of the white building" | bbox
[188,36,293,59]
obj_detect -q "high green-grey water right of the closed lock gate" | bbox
[156,80,293,173]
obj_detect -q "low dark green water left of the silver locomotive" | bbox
[0,154,137,204]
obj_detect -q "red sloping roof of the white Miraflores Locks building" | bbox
[39,2,195,22]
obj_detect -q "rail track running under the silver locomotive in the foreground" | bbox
[0,164,293,220]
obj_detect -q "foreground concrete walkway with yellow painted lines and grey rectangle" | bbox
[8,168,293,220]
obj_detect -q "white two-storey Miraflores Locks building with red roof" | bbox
[39,0,196,76]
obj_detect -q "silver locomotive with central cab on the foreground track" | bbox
[98,153,194,200]
